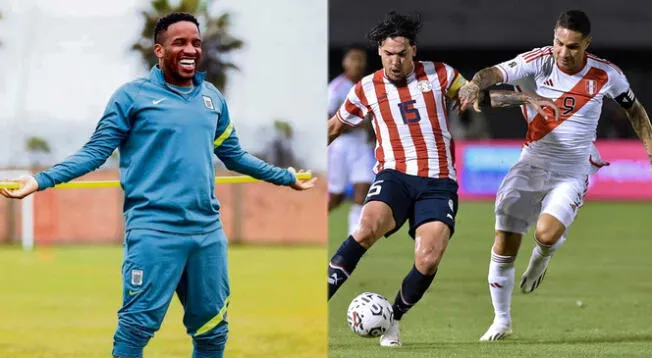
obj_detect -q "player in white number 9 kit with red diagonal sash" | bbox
[460,10,652,341]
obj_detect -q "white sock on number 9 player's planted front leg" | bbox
[487,251,516,325]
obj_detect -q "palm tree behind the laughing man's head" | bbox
[131,0,244,90]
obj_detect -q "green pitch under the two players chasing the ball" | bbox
[329,202,652,358]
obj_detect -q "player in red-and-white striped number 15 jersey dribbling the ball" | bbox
[328,12,555,347]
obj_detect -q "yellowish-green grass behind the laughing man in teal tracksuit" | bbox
[0,246,326,358]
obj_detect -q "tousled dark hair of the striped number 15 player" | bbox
[367,10,423,46]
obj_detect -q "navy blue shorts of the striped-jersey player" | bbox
[365,169,458,238]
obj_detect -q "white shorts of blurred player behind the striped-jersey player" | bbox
[328,129,376,194]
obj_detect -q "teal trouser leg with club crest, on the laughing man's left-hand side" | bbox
[113,230,191,358]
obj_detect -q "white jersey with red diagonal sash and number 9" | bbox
[496,46,634,173]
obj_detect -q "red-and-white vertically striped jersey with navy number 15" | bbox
[336,61,466,180]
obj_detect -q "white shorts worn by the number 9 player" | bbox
[496,162,588,234]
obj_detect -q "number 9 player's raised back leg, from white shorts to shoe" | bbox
[520,177,588,293]
